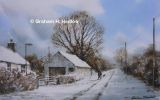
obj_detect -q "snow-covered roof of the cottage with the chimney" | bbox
[0,45,28,64]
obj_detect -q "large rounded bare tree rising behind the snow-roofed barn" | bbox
[52,11,104,70]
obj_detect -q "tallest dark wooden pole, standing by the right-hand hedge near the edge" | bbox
[153,18,156,86]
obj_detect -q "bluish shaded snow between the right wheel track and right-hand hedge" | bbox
[99,69,160,100]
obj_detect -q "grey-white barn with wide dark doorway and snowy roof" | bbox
[45,51,91,77]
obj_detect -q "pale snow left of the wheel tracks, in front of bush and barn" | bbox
[0,70,106,100]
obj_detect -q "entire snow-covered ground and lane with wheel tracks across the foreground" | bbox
[0,69,160,100]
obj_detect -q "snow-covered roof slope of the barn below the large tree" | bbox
[59,51,91,68]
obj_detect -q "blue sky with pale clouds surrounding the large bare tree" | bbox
[0,0,160,57]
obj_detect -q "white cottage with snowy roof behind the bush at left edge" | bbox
[0,45,31,74]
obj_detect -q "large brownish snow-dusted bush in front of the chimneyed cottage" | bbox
[0,68,37,94]
